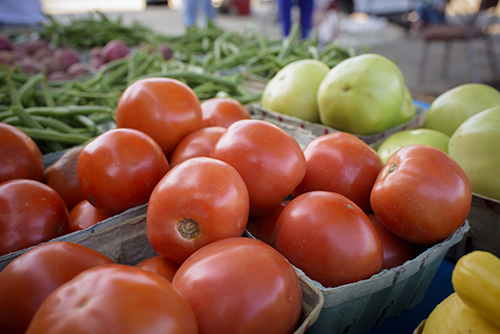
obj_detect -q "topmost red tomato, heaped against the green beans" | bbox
[116,78,202,156]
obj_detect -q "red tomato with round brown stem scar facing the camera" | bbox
[146,157,250,264]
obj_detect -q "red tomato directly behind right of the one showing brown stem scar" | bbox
[211,120,306,216]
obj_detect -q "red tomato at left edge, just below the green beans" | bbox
[0,122,44,183]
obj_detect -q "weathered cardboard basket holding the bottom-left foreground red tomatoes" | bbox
[0,204,324,334]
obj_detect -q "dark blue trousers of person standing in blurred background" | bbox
[278,0,314,38]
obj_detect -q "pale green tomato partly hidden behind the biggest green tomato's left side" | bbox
[261,59,330,123]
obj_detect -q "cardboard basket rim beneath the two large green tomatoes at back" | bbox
[249,100,428,144]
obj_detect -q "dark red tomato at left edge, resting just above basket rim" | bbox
[0,180,69,256]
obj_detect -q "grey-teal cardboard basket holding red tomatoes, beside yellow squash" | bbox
[246,221,469,334]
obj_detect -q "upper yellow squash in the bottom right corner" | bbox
[451,251,500,327]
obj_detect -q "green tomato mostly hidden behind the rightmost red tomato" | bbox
[377,129,450,164]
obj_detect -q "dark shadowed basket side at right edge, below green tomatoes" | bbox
[446,194,500,261]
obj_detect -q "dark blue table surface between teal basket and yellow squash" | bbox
[369,258,455,334]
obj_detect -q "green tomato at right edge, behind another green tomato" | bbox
[424,83,500,137]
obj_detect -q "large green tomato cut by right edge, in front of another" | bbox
[448,106,500,200]
